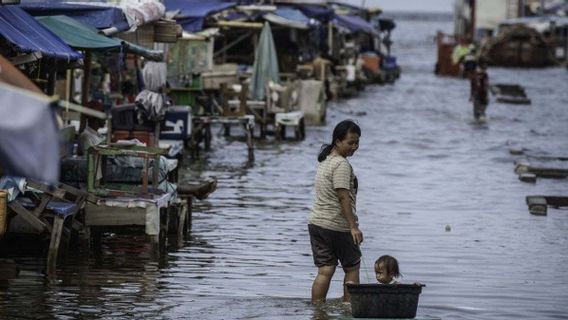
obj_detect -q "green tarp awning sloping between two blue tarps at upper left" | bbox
[36,16,163,61]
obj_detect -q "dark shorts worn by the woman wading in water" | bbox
[308,224,361,268]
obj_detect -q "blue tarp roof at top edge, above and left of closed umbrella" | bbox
[164,0,237,32]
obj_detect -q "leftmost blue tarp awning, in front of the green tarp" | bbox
[0,6,83,62]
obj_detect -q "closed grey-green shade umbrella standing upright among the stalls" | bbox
[249,23,280,100]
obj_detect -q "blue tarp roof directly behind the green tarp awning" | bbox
[20,1,130,32]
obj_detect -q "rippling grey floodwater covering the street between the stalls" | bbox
[0,12,568,320]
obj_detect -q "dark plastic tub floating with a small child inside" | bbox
[347,284,423,318]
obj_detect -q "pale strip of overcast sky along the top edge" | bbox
[340,0,454,13]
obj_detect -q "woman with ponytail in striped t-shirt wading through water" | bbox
[308,120,363,303]
